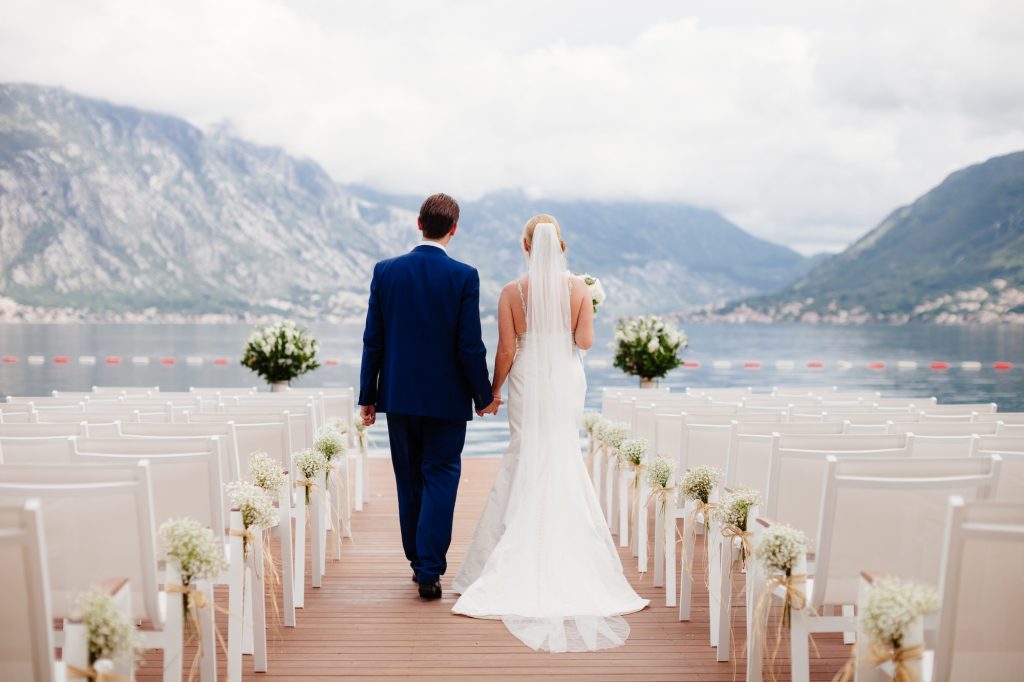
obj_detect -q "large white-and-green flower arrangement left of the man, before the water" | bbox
[242,321,319,384]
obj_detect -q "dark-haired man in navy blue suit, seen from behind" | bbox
[359,195,501,599]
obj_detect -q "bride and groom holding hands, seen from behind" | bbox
[359,195,648,651]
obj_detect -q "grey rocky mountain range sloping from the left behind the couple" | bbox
[0,85,806,317]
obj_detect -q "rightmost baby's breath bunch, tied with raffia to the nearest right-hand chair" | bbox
[858,578,939,680]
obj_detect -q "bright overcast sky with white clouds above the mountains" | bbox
[0,0,1024,253]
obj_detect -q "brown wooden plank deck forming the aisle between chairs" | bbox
[138,458,849,682]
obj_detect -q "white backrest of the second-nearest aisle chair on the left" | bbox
[0,462,164,629]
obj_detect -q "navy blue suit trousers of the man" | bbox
[387,414,466,585]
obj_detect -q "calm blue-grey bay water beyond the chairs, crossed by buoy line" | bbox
[0,323,1024,455]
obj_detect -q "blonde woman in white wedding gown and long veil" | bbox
[452,215,648,651]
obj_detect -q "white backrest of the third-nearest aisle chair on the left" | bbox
[75,446,227,536]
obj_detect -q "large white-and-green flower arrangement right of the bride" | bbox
[613,315,687,382]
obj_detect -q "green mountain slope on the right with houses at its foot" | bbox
[729,152,1024,322]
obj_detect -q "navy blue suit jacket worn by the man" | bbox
[359,245,493,421]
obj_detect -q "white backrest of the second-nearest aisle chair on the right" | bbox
[811,455,1000,612]
